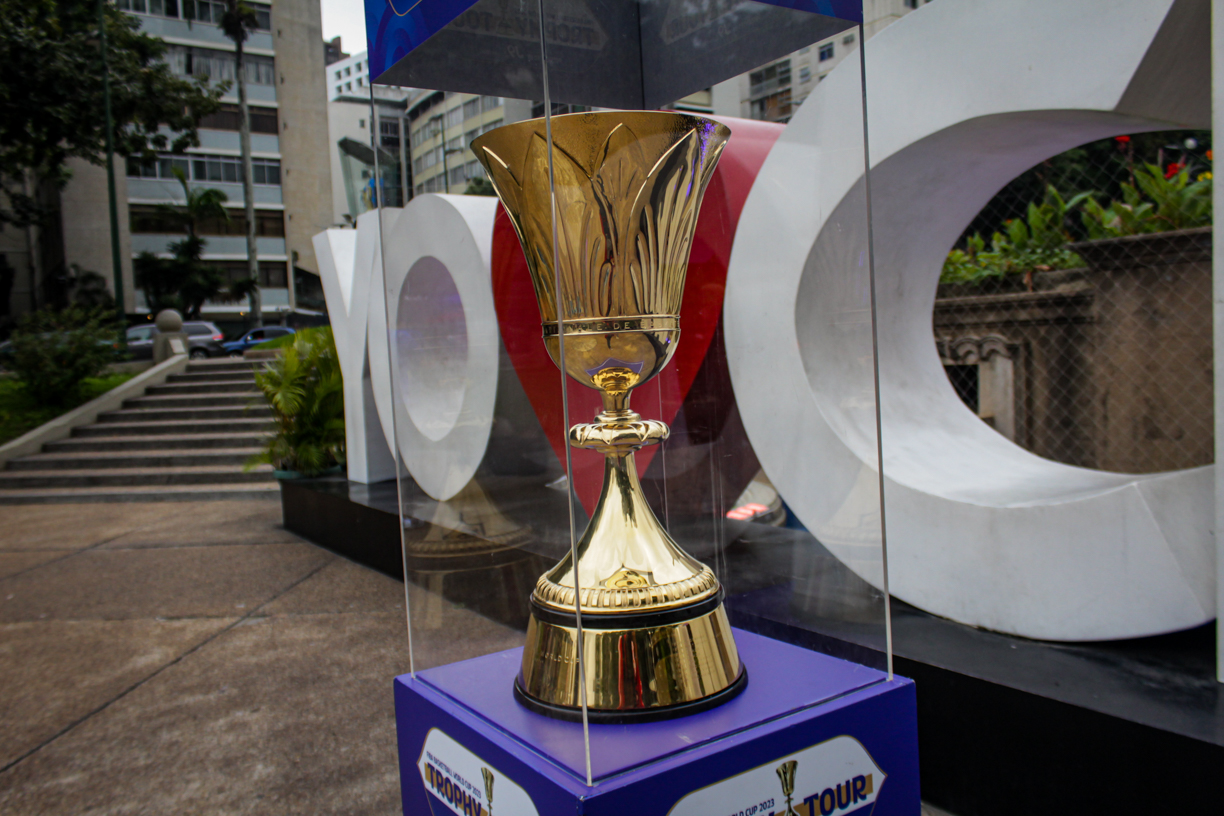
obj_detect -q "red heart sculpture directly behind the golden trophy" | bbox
[492,117,782,513]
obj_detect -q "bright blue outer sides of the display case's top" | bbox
[365,0,863,80]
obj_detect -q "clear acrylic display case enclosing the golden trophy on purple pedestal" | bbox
[369,0,891,784]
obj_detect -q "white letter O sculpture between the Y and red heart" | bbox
[368,195,499,502]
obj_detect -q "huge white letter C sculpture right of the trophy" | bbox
[725,0,1215,640]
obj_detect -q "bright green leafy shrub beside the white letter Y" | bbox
[247,327,344,476]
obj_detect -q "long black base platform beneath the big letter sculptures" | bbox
[282,478,1224,816]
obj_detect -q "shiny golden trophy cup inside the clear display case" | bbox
[471,111,748,722]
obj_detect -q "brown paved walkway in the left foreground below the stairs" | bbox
[0,500,418,816]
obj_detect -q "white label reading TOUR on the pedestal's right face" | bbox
[668,735,887,816]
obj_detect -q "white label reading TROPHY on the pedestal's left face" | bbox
[416,728,540,816]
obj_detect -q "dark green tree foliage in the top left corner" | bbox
[0,0,228,225]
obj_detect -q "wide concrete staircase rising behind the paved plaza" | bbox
[0,360,279,504]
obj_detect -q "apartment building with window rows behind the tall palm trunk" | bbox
[62,0,332,328]
